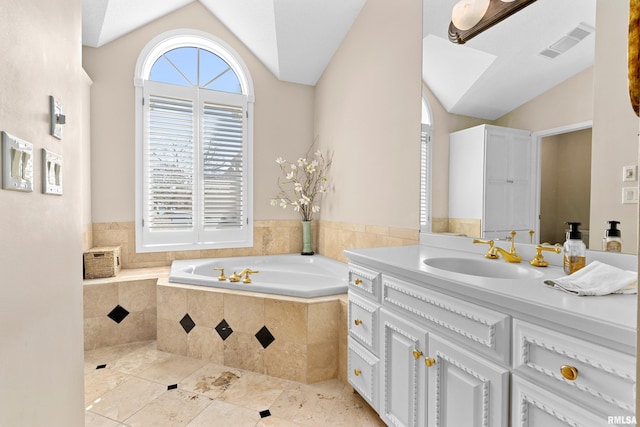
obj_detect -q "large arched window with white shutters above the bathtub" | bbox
[134,30,253,252]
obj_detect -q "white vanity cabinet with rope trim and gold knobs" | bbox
[349,254,635,427]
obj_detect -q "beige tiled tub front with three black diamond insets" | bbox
[157,280,346,384]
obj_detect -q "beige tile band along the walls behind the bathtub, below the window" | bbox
[90,220,419,268]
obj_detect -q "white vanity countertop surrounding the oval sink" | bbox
[344,240,637,355]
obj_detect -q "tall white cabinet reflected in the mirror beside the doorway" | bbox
[449,125,536,243]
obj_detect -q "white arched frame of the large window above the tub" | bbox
[134,29,254,253]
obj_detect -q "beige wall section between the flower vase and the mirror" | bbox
[315,0,422,229]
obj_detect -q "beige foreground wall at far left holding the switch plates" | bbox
[0,0,90,427]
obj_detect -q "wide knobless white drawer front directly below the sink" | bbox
[382,275,511,364]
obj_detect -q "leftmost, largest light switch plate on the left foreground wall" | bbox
[2,131,33,192]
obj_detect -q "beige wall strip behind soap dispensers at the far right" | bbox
[591,0,638,253]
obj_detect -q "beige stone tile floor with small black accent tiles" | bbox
[85,341,384,427]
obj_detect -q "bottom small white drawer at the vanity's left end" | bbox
[347,337,379,410]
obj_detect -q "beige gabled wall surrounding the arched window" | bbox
[83,2,313,223]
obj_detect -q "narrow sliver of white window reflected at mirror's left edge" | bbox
[420,96,432,233]
